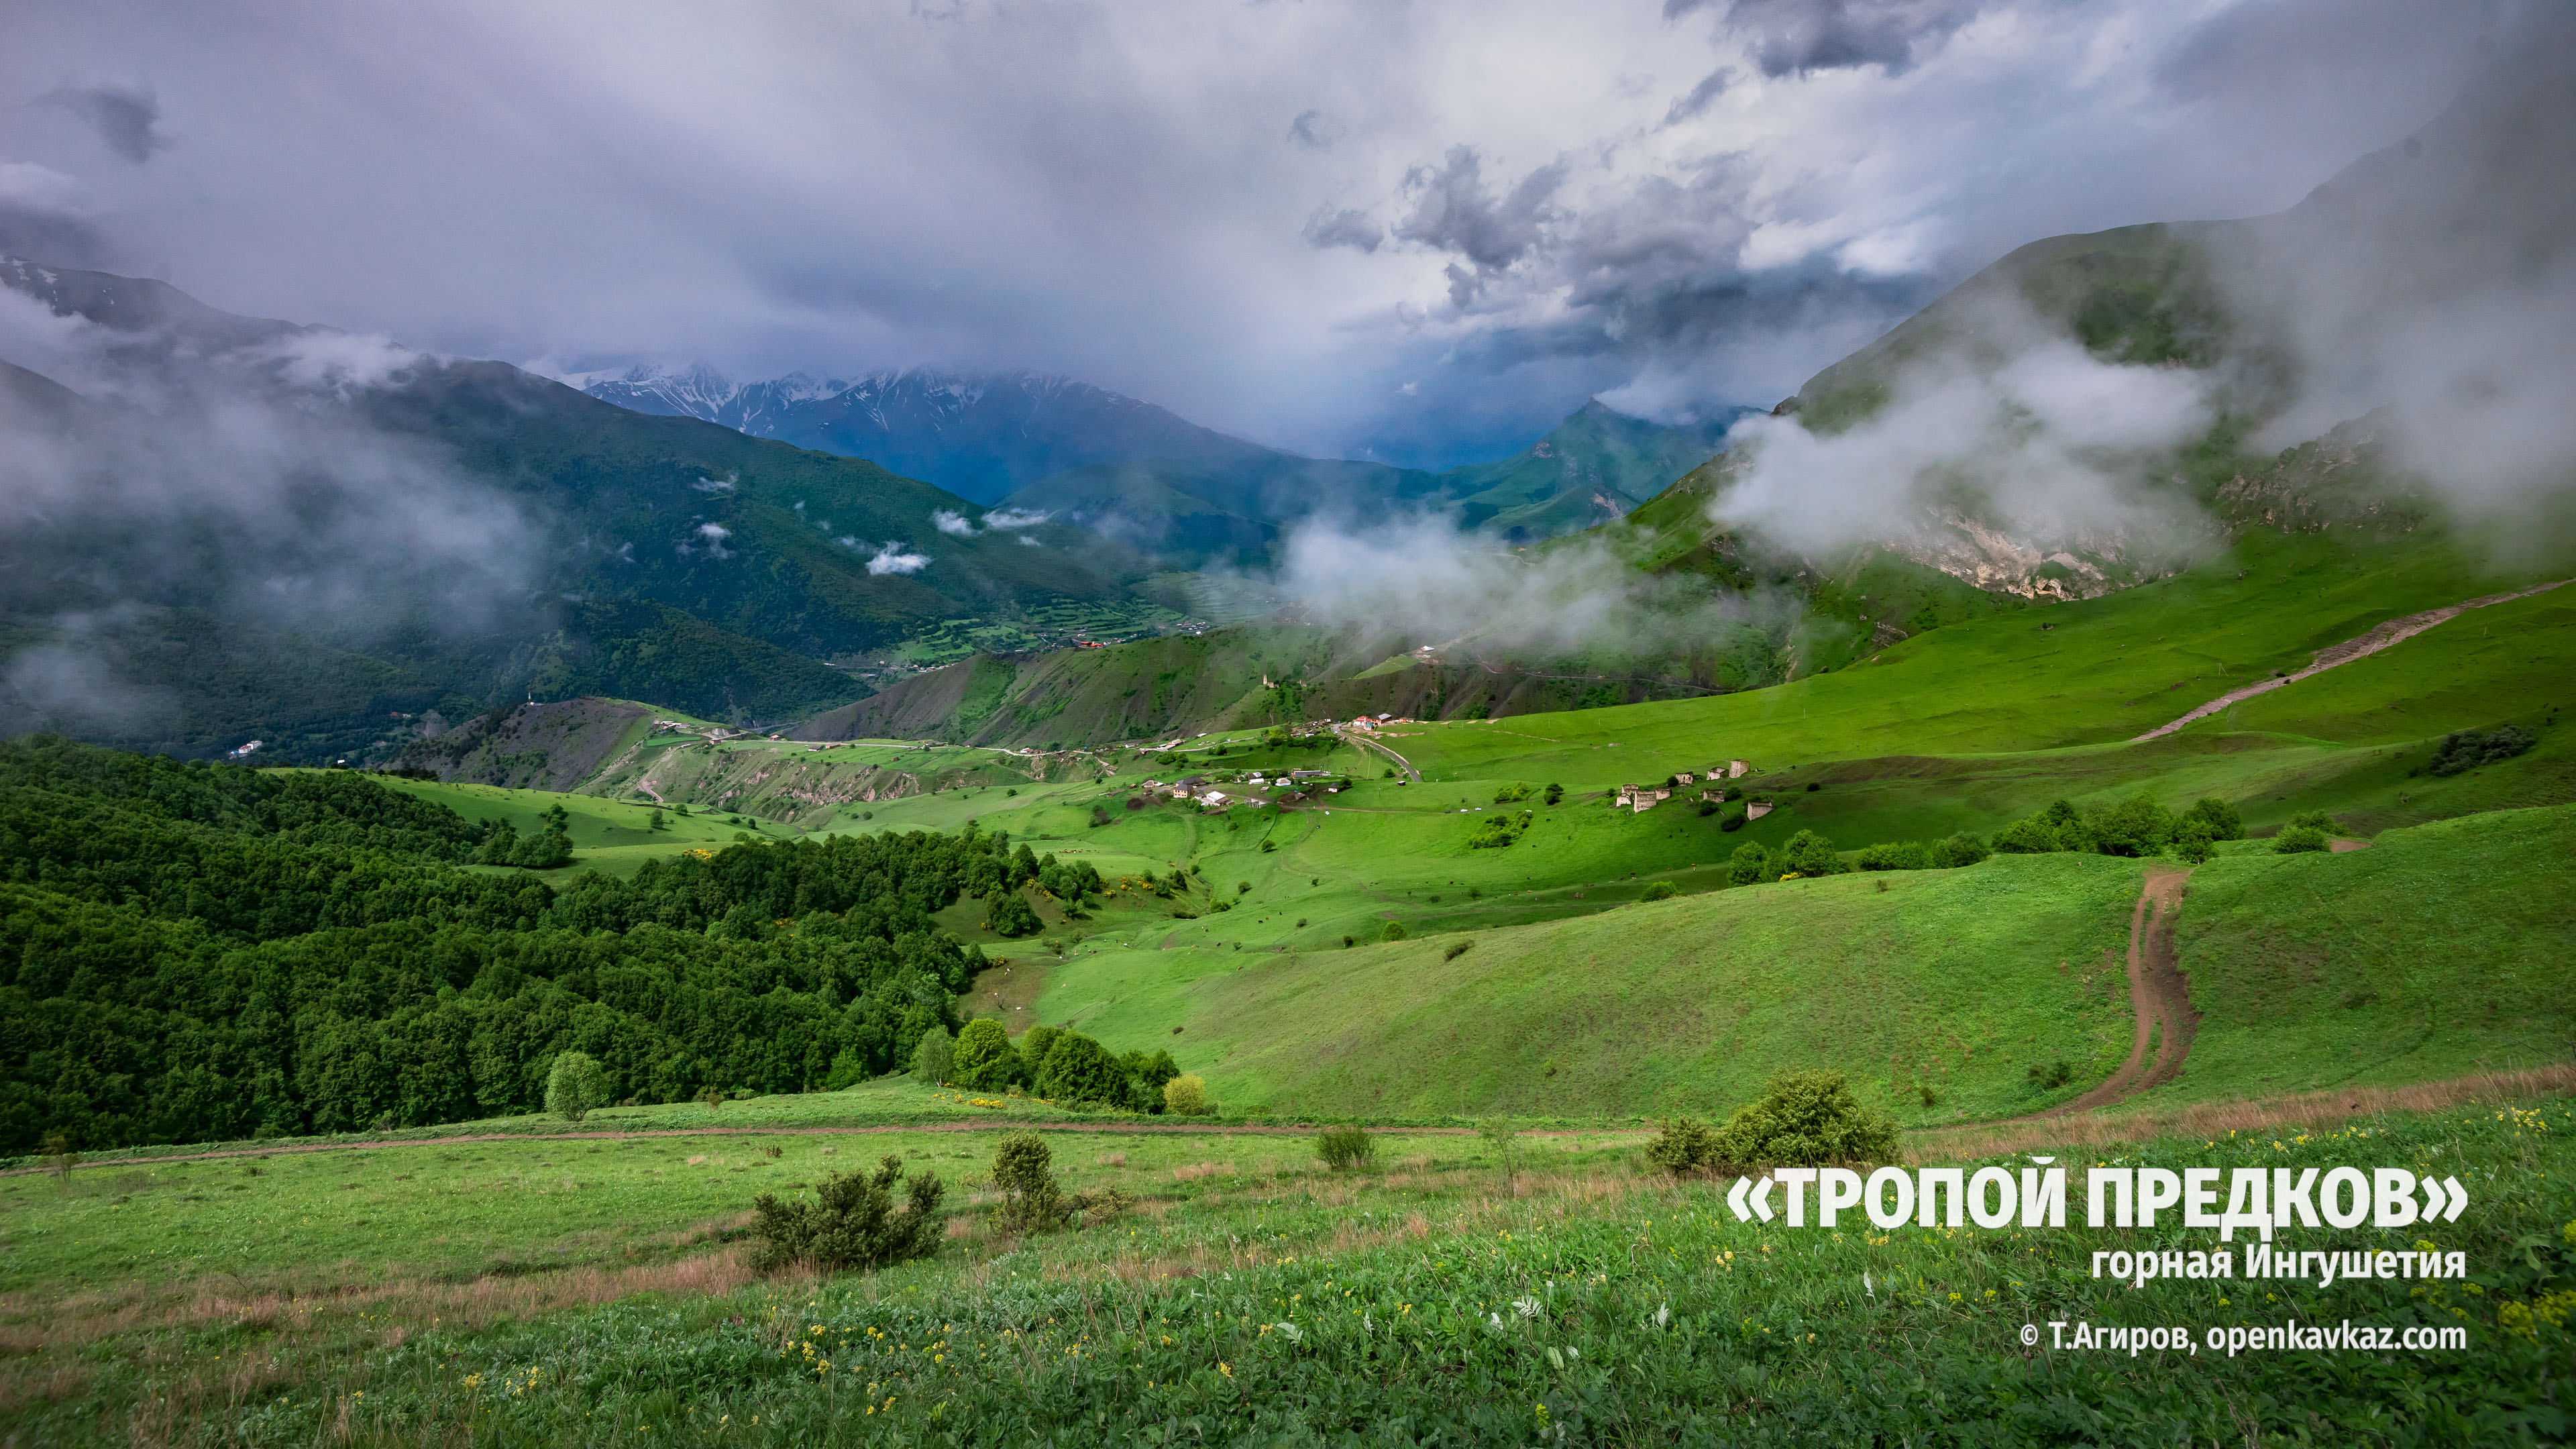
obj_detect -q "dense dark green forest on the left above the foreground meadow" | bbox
[0,737,1004,1152]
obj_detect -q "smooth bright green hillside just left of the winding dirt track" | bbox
[1038,856,2141,1124]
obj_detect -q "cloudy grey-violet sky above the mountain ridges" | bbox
[0,0,2522,464]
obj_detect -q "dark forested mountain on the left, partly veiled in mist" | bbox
[0,260,1157,761]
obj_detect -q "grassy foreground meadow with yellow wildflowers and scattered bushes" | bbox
[0,1101,2576,1446]
